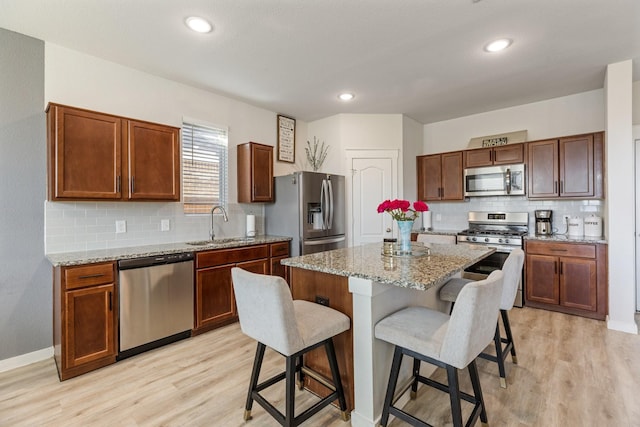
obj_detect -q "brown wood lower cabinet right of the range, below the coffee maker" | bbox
[525,241,607,320]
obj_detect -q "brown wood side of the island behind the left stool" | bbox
[290,268,354,410]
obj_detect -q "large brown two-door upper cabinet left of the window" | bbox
[47,104,180,201]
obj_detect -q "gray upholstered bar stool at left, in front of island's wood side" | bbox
[231,268,350,427]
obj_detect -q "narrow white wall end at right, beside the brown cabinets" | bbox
[605,60,638,333]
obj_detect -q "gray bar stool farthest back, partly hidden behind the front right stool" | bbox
[439,248,524,388]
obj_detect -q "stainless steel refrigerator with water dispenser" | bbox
[265,172,346,256]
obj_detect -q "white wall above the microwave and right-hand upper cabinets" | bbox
[423,89,604,154]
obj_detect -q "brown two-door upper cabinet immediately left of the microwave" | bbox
[416,151,464,201]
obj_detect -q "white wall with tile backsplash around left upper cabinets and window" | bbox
[44,43,306,253]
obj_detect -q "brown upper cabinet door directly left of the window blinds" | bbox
[127,120,180,200]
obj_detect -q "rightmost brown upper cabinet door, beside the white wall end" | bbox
[559,134,594,197]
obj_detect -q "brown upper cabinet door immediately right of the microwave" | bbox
[527,140,559,199]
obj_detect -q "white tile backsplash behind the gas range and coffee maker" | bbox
[414,196,606,234]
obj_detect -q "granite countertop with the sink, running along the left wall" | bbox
[46,235,291,267]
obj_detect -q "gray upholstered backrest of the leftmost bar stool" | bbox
[231,267,304,356]
